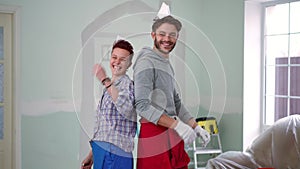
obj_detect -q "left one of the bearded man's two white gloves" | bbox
[174,120,197,144]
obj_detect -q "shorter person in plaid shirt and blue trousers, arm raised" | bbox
[81,40,137,169]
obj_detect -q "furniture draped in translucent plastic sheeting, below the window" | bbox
[206,115,300,169]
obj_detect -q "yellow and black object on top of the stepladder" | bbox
[196,117,219,134]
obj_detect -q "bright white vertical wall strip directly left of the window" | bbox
[243,1,262,150]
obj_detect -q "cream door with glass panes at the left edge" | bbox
[0,13,13,169]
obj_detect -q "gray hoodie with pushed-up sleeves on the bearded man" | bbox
[133,47,192,124]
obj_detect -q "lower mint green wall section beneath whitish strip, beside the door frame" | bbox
[21,112,80,169]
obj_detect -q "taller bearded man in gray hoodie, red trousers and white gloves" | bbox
[133,8,210,169]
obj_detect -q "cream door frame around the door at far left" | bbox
[0,5,22,169]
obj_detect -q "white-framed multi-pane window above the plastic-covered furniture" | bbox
[263,1,300,125]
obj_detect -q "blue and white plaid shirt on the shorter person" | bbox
[92,75,137,152]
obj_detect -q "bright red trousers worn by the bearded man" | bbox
[137,119,190,169]
